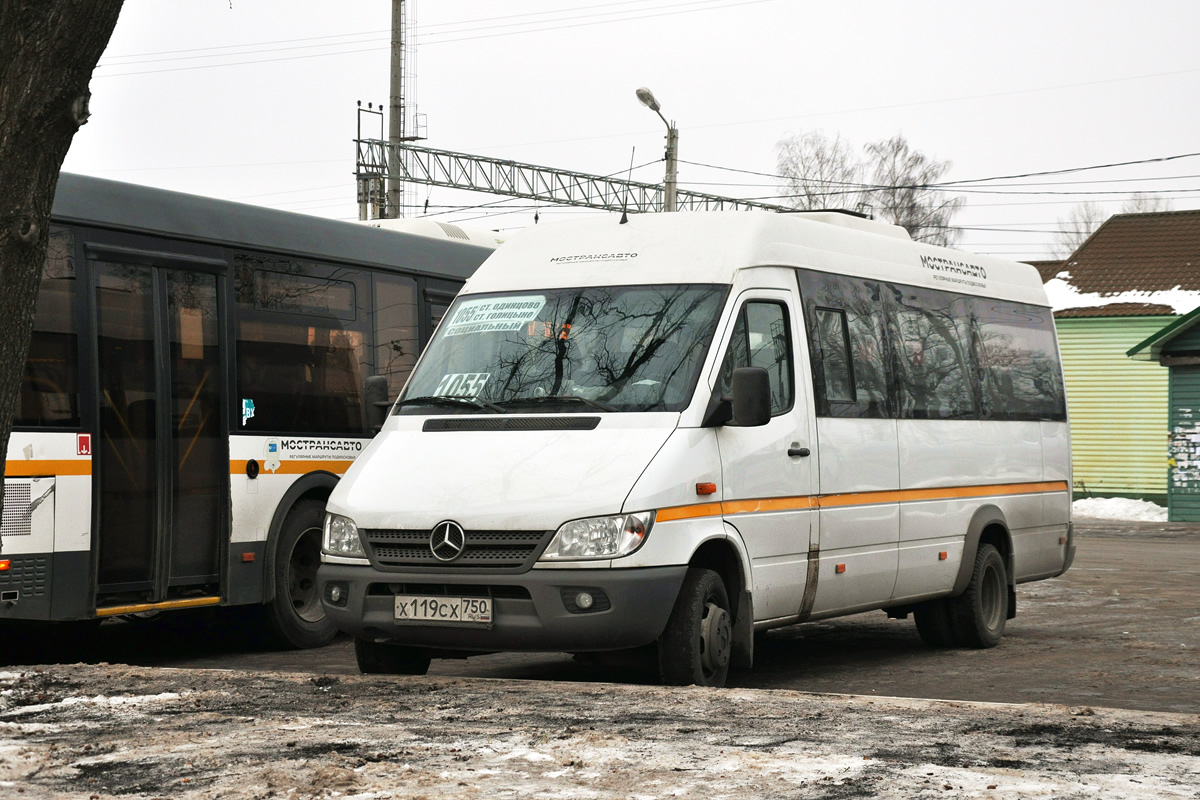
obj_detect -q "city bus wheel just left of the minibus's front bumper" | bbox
[266,500,337,650]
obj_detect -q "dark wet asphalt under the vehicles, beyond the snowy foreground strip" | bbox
[0,521,1200,714]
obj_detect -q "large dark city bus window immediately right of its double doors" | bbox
[234,253,371,434]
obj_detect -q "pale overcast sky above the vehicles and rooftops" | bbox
[64,0,1200,259]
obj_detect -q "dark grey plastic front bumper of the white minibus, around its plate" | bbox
[317,564,688,652]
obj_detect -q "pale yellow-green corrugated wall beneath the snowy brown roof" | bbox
[1055,317,1176,496]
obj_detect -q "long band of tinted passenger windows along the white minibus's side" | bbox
[797,270,1067,421]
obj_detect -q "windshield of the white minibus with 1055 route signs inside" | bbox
[394,284,728,414]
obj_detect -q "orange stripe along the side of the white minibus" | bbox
[655,481,1067,522]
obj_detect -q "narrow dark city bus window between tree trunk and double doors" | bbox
[12,229,79,427]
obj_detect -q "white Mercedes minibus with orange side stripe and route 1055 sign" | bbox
[318,212,1074,686]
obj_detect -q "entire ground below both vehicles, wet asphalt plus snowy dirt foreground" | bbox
[0,523,1200,800]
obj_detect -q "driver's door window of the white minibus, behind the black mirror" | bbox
[720,300,796,416]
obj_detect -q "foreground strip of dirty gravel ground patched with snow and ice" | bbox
[0,664,1200,800]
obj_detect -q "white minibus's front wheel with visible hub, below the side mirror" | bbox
[658,567,733,687]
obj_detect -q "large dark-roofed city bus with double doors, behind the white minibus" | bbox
[0,174,496,648]
